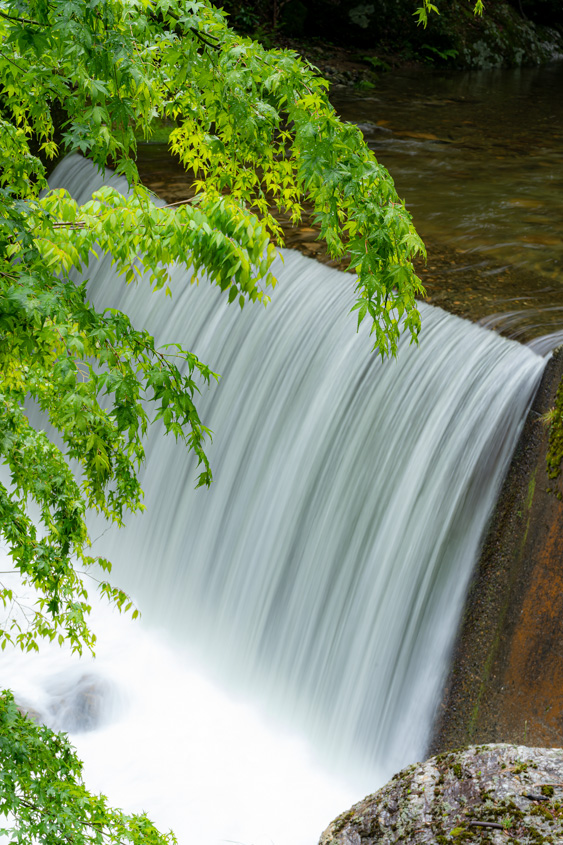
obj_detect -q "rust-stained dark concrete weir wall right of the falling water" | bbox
[430,347,563,753]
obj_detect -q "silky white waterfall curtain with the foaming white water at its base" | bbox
[0,153,543,845]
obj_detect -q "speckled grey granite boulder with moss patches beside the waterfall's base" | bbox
[319,745,563,845]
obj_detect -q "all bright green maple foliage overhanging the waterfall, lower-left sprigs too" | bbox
[0,0,423,845]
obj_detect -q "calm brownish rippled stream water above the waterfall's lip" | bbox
[333,63,563,334]
